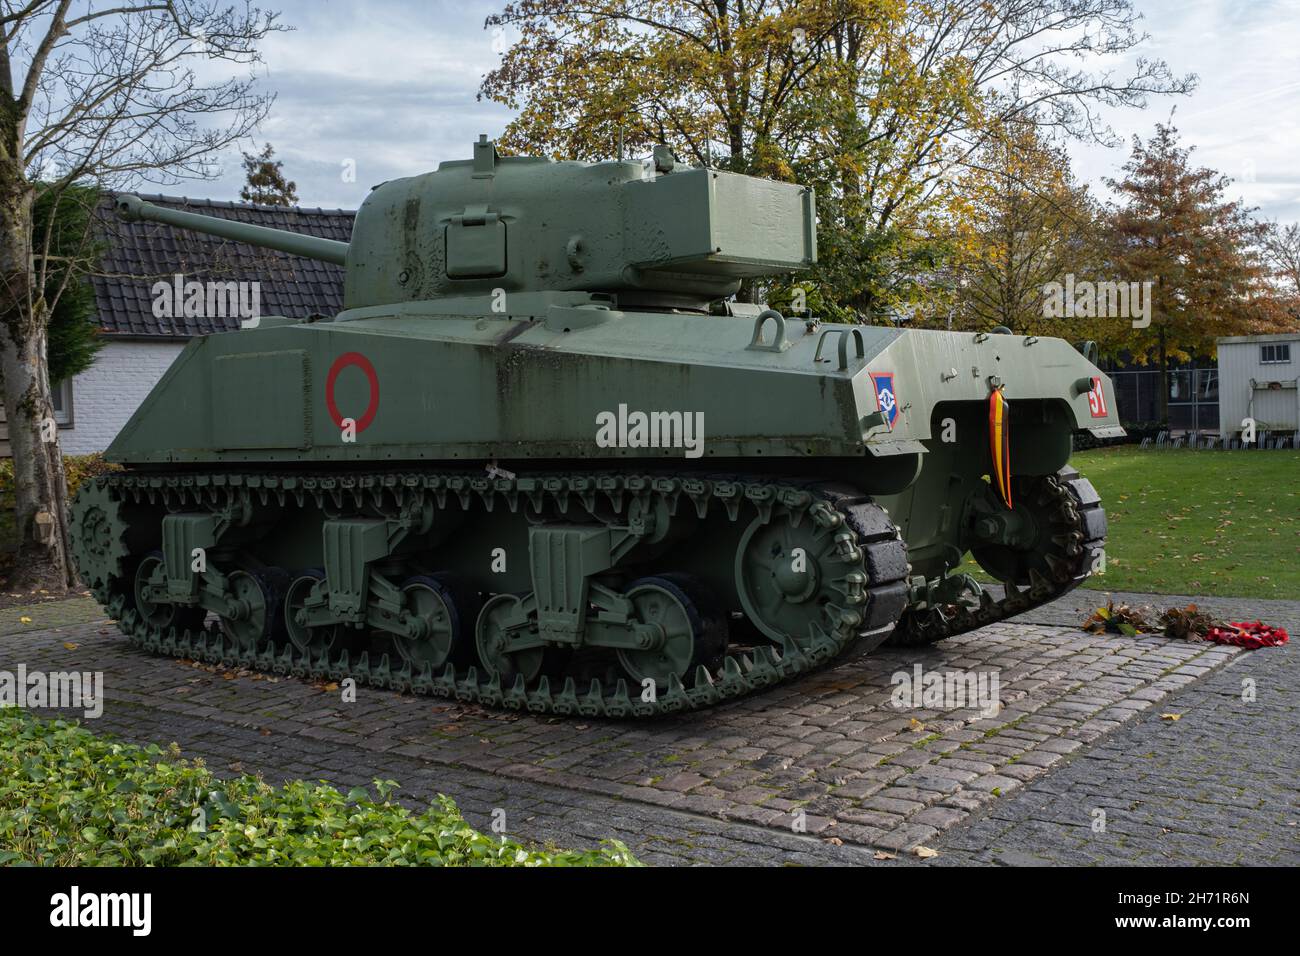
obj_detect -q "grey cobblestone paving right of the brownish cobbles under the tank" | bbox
[931,594,1300,866]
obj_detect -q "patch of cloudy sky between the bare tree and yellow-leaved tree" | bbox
[149,0,510,208]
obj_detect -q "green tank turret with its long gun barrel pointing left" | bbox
[117,137,816,308]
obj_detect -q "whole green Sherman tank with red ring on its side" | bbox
[72,138,1122,717]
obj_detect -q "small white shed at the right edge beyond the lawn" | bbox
[1218,332,1300,436]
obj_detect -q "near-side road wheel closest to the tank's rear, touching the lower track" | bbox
[619,575,727,689]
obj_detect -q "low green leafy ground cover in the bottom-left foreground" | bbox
[0,708,641,866]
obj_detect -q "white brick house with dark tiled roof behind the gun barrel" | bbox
[0,195,355,458]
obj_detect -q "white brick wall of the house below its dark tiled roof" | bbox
[59,341,185,455]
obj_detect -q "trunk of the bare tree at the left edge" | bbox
[0,170,75,587]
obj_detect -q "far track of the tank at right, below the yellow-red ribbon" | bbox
[888,468,1106,646]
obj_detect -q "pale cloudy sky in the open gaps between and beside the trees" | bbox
[166,0,1300,221]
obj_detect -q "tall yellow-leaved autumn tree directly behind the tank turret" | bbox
[480,0,1193,321]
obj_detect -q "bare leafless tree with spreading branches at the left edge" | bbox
[0,0,282,584]
